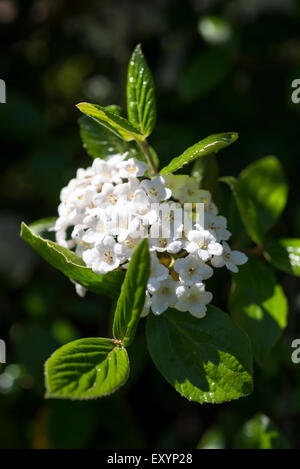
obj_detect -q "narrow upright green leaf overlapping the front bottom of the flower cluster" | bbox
[113,239,150,346]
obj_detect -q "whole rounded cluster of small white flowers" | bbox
[54,154,247,318]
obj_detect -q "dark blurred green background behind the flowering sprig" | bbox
[0,0,300,448]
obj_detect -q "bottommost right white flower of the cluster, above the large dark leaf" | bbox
[175,283,213,318]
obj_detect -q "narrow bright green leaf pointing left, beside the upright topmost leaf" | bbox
[77,103,143,142]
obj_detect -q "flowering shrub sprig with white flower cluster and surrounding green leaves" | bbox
[21,46,292,403]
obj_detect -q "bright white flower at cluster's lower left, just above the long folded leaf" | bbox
[82,236,120,275]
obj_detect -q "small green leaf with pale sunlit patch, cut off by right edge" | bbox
[265,239,300,277]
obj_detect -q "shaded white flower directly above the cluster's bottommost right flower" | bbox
[174,254,213,285]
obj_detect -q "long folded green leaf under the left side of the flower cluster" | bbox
[21,223,124,297]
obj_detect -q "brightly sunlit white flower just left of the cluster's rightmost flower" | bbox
[186,229,223,262]
